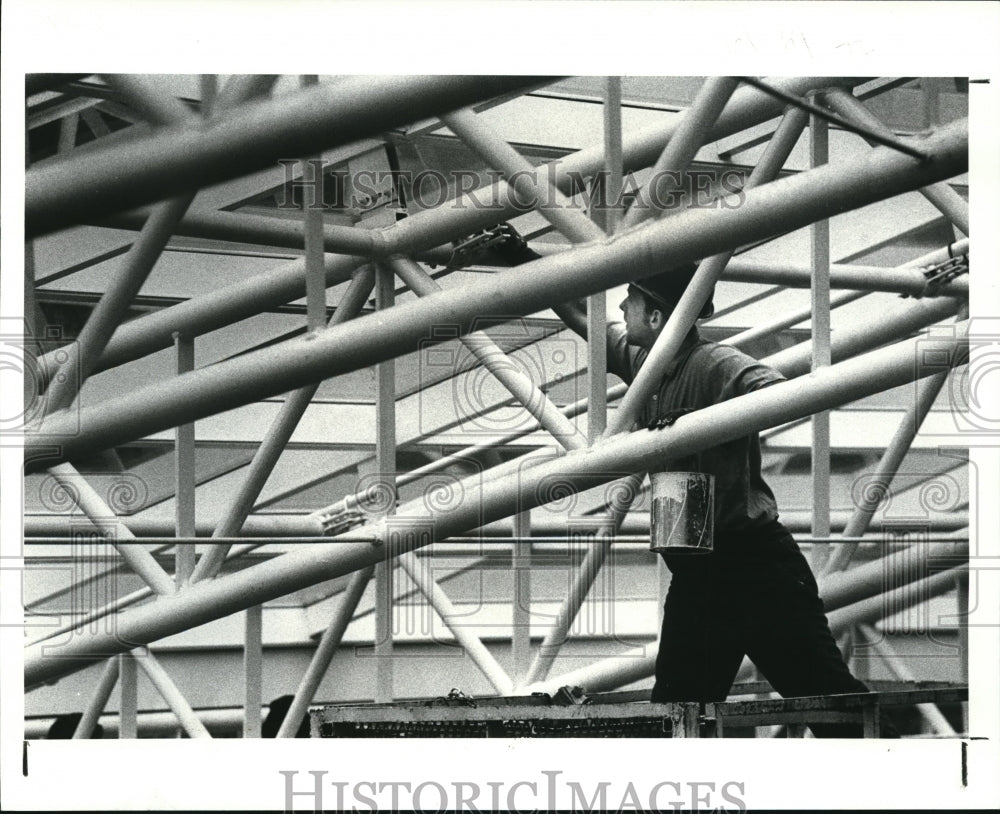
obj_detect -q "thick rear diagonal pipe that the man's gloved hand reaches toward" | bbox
[39,77,863,378]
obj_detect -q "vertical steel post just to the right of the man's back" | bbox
[809,116,831,573]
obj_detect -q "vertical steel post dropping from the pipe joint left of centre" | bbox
[375,267,396,703]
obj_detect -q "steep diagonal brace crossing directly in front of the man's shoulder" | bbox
[606,105,807,435]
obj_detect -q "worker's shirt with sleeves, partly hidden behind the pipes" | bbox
[608,322,784,536]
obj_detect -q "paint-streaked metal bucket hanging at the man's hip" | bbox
[649,472,715,554]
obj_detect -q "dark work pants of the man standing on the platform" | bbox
[653,522,891,737]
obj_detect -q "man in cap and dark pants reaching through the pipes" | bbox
[496,230,897,737]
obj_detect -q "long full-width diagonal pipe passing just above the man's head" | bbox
[25,118,967,468]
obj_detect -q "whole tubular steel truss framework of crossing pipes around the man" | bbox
[25,77,968,737]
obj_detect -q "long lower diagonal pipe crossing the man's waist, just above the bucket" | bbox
[25,322,968,687]
